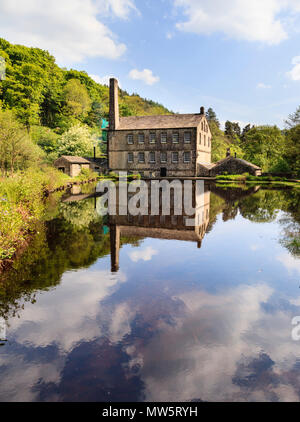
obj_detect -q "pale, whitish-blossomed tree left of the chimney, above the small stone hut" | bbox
[57,125,97,156]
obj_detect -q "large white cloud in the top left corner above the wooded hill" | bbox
[0,0,134,65]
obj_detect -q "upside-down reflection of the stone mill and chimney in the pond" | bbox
[109,185,210,272]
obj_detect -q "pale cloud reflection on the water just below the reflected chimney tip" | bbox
[9,270,126,353]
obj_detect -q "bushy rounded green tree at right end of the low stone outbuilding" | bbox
[243,126,286,171]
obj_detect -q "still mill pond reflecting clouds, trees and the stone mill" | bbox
[0,184,300,402]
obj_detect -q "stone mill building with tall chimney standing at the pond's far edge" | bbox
[108,79,211,178]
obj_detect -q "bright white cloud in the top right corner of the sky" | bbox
[174,0,300,44]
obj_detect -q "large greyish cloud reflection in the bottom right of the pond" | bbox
[123,285,299,401]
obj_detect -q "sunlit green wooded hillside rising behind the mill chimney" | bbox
[0,38,170,138]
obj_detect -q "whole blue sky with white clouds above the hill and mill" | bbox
[0,0,300,127]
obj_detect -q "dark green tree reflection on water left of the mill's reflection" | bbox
[0,199,136,318]
